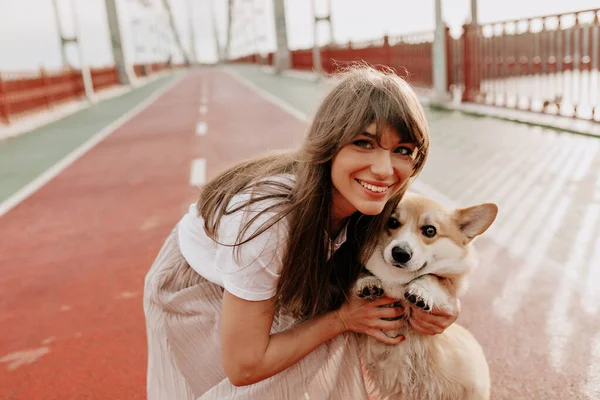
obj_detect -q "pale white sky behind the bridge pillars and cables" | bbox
[0,0,600,73]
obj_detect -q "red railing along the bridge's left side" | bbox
[0,64,176,123]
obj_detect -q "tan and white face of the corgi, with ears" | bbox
[366,193,498,284]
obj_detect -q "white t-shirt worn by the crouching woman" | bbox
[178,175,347,301]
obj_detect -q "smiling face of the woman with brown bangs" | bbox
[331,123,415,221]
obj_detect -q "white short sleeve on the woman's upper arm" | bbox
[215,194,288,301]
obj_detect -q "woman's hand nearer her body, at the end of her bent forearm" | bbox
[335,296,406,344]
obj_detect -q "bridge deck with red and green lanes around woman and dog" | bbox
[0,67,600,399]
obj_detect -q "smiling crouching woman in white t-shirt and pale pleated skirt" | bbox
[144,66,458,400]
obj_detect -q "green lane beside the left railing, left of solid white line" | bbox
[0,74,177,203]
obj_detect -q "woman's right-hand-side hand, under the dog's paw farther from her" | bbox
[408,282,460,335]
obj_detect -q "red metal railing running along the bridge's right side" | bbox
[236,8,600,122]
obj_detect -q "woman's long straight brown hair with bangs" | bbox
[198,64,429,318]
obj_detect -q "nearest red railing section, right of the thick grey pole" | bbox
[462,9,600,121]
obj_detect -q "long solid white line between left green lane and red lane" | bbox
[0,75,185,217]
